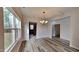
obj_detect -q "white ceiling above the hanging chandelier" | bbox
[19,7,72,18]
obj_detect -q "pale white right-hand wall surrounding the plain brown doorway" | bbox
[52,16,71,41]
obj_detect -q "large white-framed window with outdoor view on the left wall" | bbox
[4,8,21,51]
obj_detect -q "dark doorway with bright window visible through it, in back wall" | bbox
[29,22,37,39]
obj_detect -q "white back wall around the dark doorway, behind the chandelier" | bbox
[25,18,51,40]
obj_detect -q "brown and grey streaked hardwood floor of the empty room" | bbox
[24,38,79,52]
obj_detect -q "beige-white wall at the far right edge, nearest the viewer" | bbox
[65,8,79,49]
